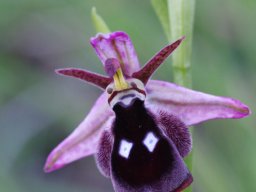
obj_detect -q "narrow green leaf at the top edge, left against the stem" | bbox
[151,0,171,41]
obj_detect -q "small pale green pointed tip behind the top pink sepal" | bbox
[92,7,111,33]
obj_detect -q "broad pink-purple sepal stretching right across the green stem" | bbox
[146,80,250,126]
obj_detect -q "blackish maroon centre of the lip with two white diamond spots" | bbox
[111,99,191,192]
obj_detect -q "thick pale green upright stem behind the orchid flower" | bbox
[167,0,195,192]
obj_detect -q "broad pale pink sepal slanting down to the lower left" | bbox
[44,92,114,172]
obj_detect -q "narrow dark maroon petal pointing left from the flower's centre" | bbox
[56,68,112,90]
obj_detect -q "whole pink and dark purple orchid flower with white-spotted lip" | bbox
[45,32,250,192]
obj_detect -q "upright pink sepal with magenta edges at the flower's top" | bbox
[91,31,139,76]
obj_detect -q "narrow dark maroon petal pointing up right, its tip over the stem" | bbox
[132,37,185,84]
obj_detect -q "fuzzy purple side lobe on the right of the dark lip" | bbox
[155,111,192,157]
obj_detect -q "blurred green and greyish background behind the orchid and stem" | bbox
[0,0,256,192]
